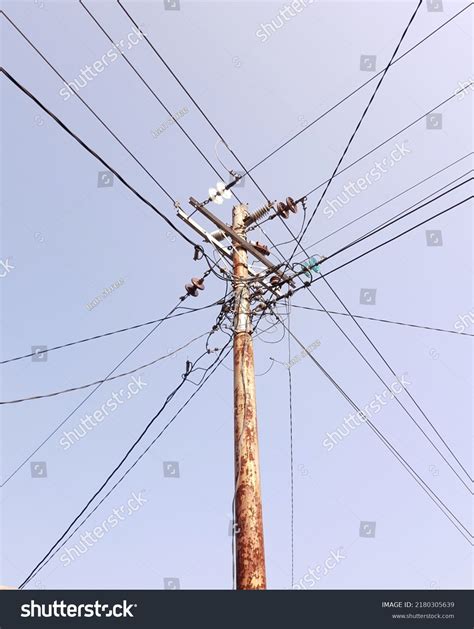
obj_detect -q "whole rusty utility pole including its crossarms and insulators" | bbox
[177,193,304,590]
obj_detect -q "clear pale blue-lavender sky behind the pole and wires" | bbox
[0,0,474,589]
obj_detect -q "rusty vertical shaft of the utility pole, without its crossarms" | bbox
[232,205,266,590]
